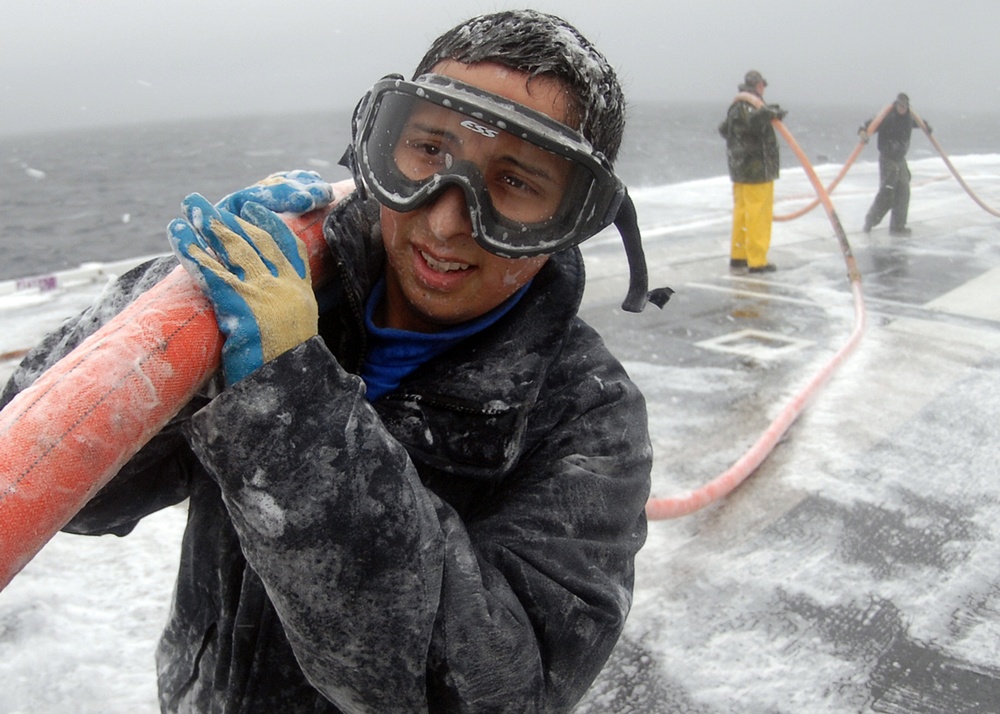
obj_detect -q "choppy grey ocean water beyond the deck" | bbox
[0,103,1000,280]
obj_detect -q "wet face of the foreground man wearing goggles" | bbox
[376,60,568,332]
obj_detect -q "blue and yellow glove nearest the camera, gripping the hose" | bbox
[167,193,319,385]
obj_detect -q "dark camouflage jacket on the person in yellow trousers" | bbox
[719,93,779,183]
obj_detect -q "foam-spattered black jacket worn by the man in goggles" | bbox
[0,193,651,714]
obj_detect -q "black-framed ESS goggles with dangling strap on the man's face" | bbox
[341,74,669,312]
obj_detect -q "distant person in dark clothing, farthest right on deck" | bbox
[858,92,930,236]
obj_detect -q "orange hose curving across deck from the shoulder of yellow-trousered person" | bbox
[646,98,865,520]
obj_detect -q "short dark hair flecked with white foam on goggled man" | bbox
[413,10,625,163]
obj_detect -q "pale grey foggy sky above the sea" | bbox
[0,0,1000,133]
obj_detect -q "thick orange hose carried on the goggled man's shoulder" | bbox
[0,182,353,590]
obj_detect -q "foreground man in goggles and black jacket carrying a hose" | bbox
[4,6,672,714]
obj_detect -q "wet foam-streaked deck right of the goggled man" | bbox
[578,159,1000,713]
